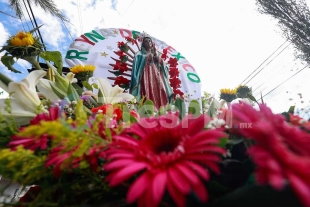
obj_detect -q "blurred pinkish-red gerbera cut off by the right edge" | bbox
[232,104,310,206]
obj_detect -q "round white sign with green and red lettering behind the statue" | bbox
[65,28,201,105]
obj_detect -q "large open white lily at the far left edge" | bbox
[0,70,46,125]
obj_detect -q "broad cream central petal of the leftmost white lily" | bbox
[9,81,41,112]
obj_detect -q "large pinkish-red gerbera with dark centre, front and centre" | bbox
[104,113,225,207]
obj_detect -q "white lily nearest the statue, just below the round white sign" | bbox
[95,78,135,104]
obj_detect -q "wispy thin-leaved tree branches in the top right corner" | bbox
[256,0,310,63]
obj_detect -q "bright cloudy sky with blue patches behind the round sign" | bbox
[0,0,310,116]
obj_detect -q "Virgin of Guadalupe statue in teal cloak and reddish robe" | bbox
[129,34,174,109]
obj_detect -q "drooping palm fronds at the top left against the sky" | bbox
[9,0,67,21]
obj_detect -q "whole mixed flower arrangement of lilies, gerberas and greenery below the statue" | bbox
[0,29,310,207]
